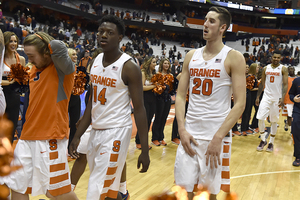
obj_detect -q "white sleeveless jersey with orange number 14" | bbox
[91,53,132,129]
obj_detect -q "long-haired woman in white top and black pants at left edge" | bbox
[1,31,25,139]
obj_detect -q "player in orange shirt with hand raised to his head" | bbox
[1,32,77,200]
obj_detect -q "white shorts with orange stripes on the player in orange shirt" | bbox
[4,138,71,196]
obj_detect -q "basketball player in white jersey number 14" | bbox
[70,15,150,200]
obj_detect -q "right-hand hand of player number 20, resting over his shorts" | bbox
[205,137,222,169]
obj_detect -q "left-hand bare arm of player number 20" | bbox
[175,50,197,156]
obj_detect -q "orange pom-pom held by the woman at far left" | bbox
[8,63,30,85]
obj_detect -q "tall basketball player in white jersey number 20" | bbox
[174,7,246,200]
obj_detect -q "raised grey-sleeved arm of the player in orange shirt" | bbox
[49,40,75,75]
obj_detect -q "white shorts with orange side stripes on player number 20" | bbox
[174,139,231,194]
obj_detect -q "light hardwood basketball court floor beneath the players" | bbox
[31,106,300,200]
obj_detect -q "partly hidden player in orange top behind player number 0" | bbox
[282,66,297,134]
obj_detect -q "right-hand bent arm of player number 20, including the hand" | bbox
[205,50,246,168]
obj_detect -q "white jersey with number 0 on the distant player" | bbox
[263,64,283,101]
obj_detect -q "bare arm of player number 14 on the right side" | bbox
[122,60,150,172]
